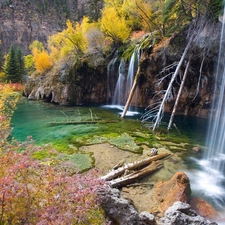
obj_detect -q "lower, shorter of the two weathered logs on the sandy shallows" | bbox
[109,161,163,188]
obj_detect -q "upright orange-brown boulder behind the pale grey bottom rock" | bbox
[155,172,191,213]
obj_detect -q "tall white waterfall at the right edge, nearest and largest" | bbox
[204,7,225,190]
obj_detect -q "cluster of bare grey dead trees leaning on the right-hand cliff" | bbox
[141,18,217,131]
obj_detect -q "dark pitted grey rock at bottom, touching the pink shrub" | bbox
[98,187,156,225]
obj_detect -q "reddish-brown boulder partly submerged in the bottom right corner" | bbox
[189,198,218,219]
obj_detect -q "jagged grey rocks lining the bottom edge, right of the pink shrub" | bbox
[98,187,217,225]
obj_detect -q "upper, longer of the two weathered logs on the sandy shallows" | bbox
[101,153,170,181]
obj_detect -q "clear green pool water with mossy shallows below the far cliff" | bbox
[11,98,206,170]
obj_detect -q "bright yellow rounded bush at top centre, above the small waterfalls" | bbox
[101,7,131,44]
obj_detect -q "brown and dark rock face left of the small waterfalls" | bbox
[24,61,107,105]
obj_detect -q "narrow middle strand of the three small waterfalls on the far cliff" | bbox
[112,59,125,105]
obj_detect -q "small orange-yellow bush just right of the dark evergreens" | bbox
[32,48,53,73]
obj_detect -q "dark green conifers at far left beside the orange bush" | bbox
[5,46,24,83]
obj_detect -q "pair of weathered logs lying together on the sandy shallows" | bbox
[101,153,170,187]
